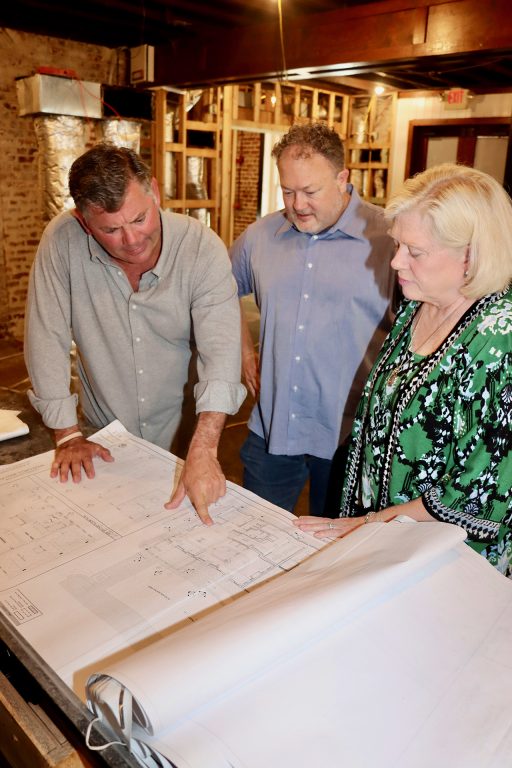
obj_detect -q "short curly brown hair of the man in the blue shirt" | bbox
[272,123,345,172]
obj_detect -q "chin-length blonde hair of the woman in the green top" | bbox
[385,163,512,299]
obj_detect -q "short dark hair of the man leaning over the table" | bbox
[69,142,152,213]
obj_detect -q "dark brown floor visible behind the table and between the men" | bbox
[0,297,308,515]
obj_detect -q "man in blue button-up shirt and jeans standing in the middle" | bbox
[230,124,394,515]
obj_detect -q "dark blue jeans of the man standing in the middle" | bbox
[240,431,332,517]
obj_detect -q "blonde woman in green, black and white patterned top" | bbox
[296,163,512,576]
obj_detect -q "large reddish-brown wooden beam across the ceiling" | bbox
[155,0,512,87]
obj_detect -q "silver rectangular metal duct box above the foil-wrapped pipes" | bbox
[16,74,102,118]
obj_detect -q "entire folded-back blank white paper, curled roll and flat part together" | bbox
[93,522,512,768]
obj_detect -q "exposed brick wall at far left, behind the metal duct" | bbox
[0,27,126,339]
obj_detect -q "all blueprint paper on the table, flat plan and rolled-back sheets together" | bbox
[0,423,512,768]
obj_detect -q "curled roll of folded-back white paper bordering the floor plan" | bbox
[90,523,464,732]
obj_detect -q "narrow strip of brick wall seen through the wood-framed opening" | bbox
[233,131,263,239]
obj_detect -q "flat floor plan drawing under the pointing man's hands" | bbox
[0,423,324,697]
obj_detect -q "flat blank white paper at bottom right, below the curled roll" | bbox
[165,550,512,768]
